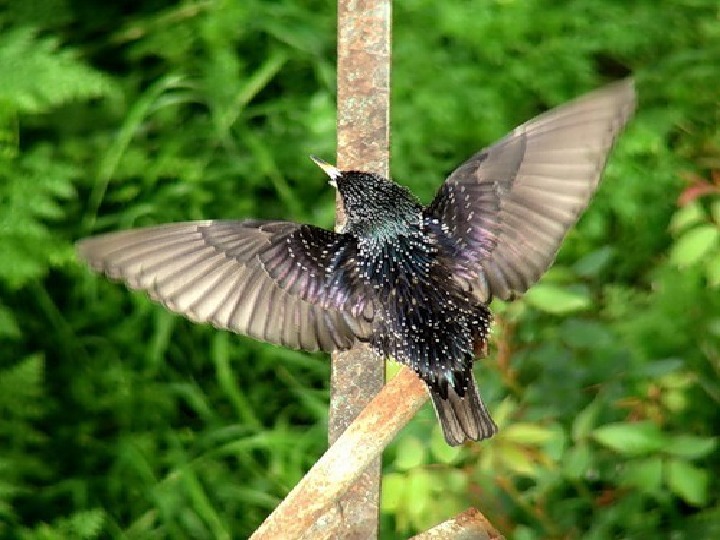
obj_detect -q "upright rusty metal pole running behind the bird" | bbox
[328,0,391,540]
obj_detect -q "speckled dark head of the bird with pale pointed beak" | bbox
[312,157,422,233]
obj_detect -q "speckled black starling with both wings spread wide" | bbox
[77,79,636,446]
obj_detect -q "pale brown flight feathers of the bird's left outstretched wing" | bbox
[78,220,371,351]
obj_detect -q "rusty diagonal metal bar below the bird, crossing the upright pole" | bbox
[251,368,428,540]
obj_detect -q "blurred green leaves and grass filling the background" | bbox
[0,0,720,540]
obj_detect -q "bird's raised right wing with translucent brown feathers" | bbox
[426,80,635,301]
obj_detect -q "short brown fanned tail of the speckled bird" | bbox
[428,372,498,446]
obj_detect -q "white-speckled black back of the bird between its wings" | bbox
[358,223,490,395]
